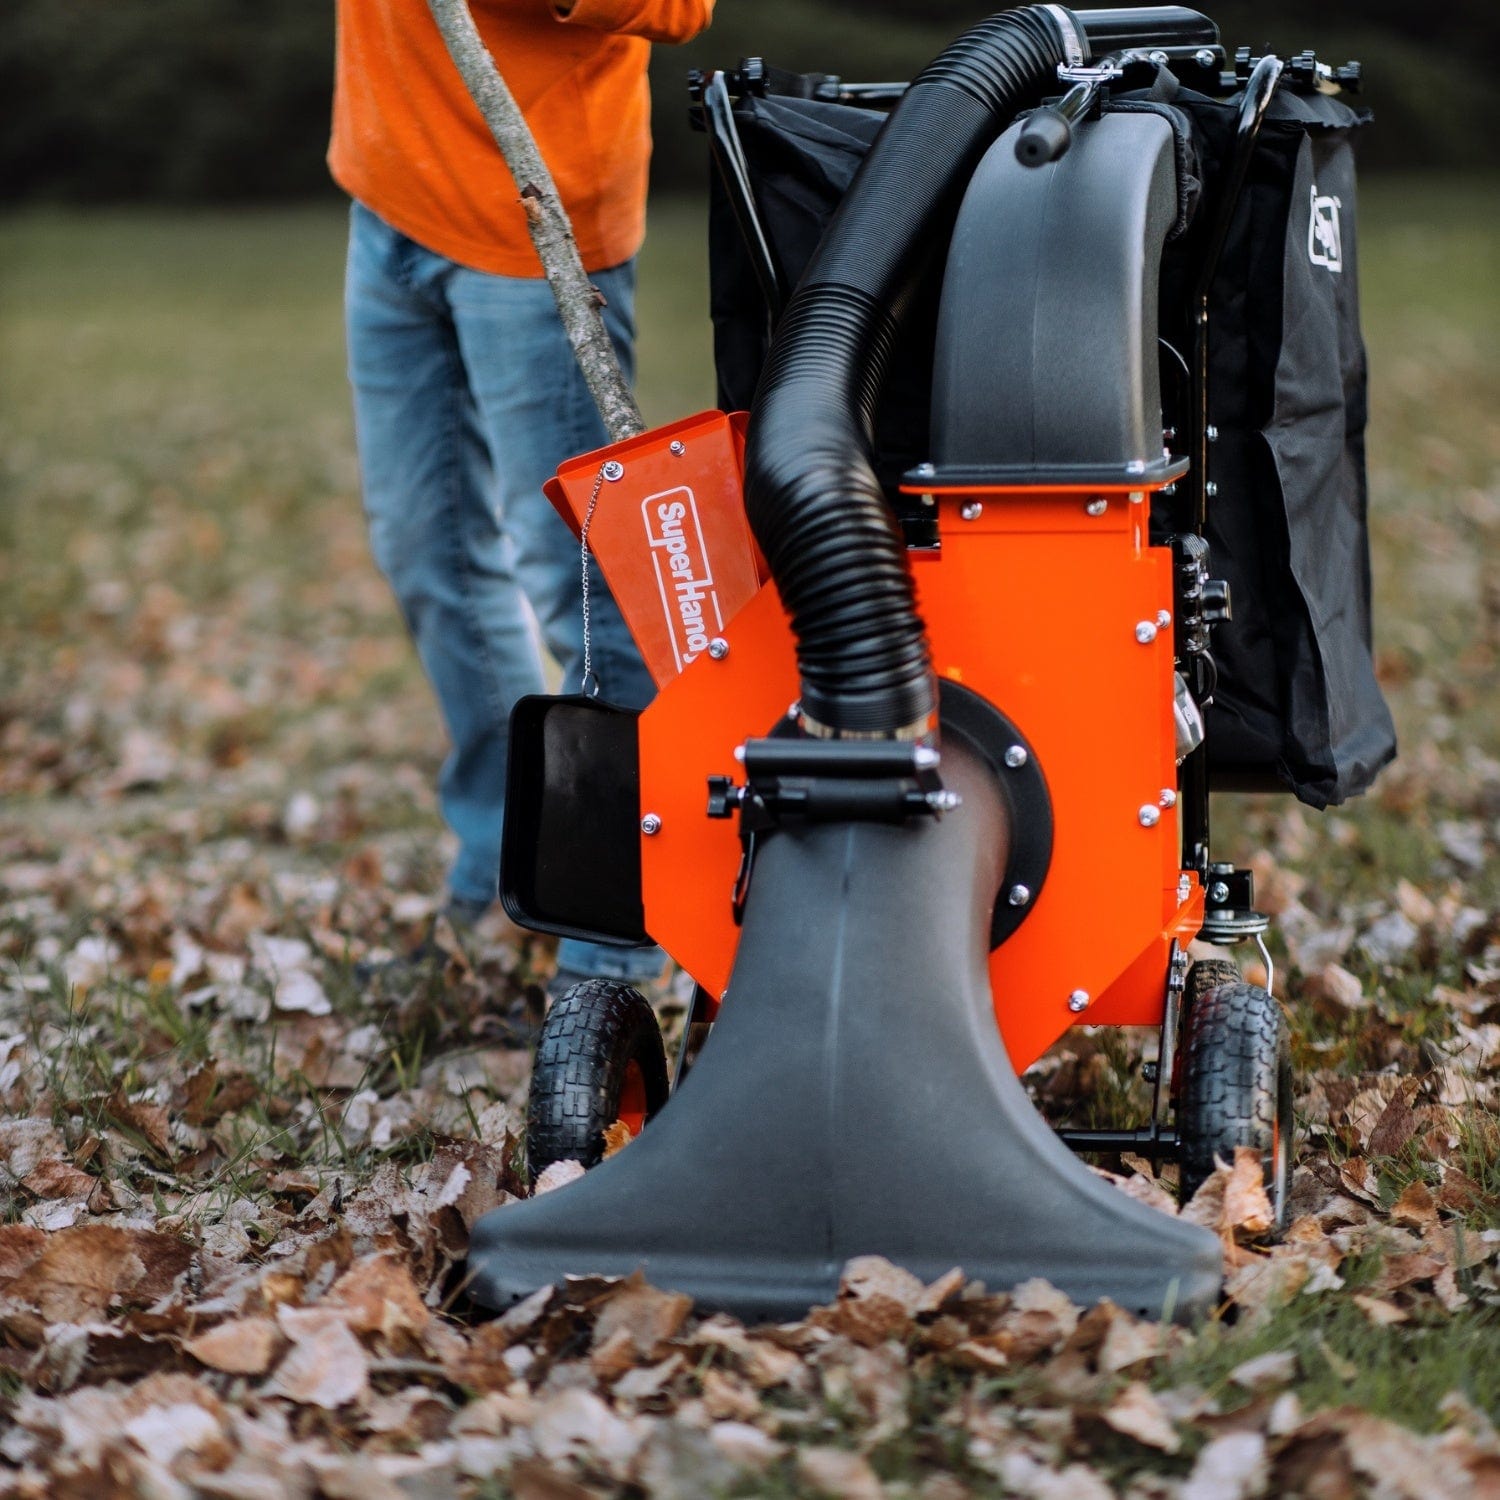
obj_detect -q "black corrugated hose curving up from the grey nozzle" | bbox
[746,6,1083,737]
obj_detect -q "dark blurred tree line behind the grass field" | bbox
[0,0,1500,203]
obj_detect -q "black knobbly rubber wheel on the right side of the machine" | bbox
[1178,978,1292,1230]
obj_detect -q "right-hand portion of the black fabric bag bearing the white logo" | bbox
[1164,90,1397,807]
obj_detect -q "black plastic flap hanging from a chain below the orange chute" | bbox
[500,698,651,948]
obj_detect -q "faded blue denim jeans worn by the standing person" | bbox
[345,203,663,980]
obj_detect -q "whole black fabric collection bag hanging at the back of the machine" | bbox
[710,79,1395,807]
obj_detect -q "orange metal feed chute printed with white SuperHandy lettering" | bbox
[546,411,764,686]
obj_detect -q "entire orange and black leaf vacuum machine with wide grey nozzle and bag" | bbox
[470,5,1395,1320]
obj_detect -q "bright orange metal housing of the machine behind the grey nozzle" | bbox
[641,491,1202,1070]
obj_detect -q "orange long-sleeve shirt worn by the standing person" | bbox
[329,0,714,276]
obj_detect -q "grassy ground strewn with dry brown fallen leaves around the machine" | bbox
[0,183,1500,1500]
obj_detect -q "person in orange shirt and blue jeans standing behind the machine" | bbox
[329,0,713,992]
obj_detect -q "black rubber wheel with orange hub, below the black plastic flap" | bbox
[527,980,668,1181]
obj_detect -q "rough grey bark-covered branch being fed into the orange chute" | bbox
[428,0,647,443]
